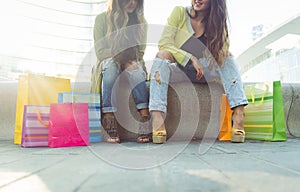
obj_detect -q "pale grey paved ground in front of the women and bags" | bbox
[0,138,300,192]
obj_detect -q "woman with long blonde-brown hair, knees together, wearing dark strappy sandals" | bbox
[91,0,151,143]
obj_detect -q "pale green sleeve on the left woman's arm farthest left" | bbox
[94,12,111,61]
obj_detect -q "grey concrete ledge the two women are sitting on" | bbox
[0,82,300,140]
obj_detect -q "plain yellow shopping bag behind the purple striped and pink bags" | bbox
[14,74,71,144]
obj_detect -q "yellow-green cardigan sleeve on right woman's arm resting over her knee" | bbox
[159,6,192,66]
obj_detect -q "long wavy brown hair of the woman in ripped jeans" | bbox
[189,0,230,66]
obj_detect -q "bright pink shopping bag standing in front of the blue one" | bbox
[48,103,90,148]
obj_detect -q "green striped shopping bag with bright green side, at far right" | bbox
[244,81,287,141]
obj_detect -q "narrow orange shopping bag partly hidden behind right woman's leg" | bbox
[219,94,233,141]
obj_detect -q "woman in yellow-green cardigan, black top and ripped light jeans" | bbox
[149,0,248,143]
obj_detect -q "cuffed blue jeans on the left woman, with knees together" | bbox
[102,59,149,113]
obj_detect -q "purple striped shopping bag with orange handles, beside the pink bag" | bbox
[21,105,50,147]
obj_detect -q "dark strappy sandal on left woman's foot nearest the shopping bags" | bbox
[103,117,120,143]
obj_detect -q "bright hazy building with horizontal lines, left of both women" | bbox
[0,0,107,80]
